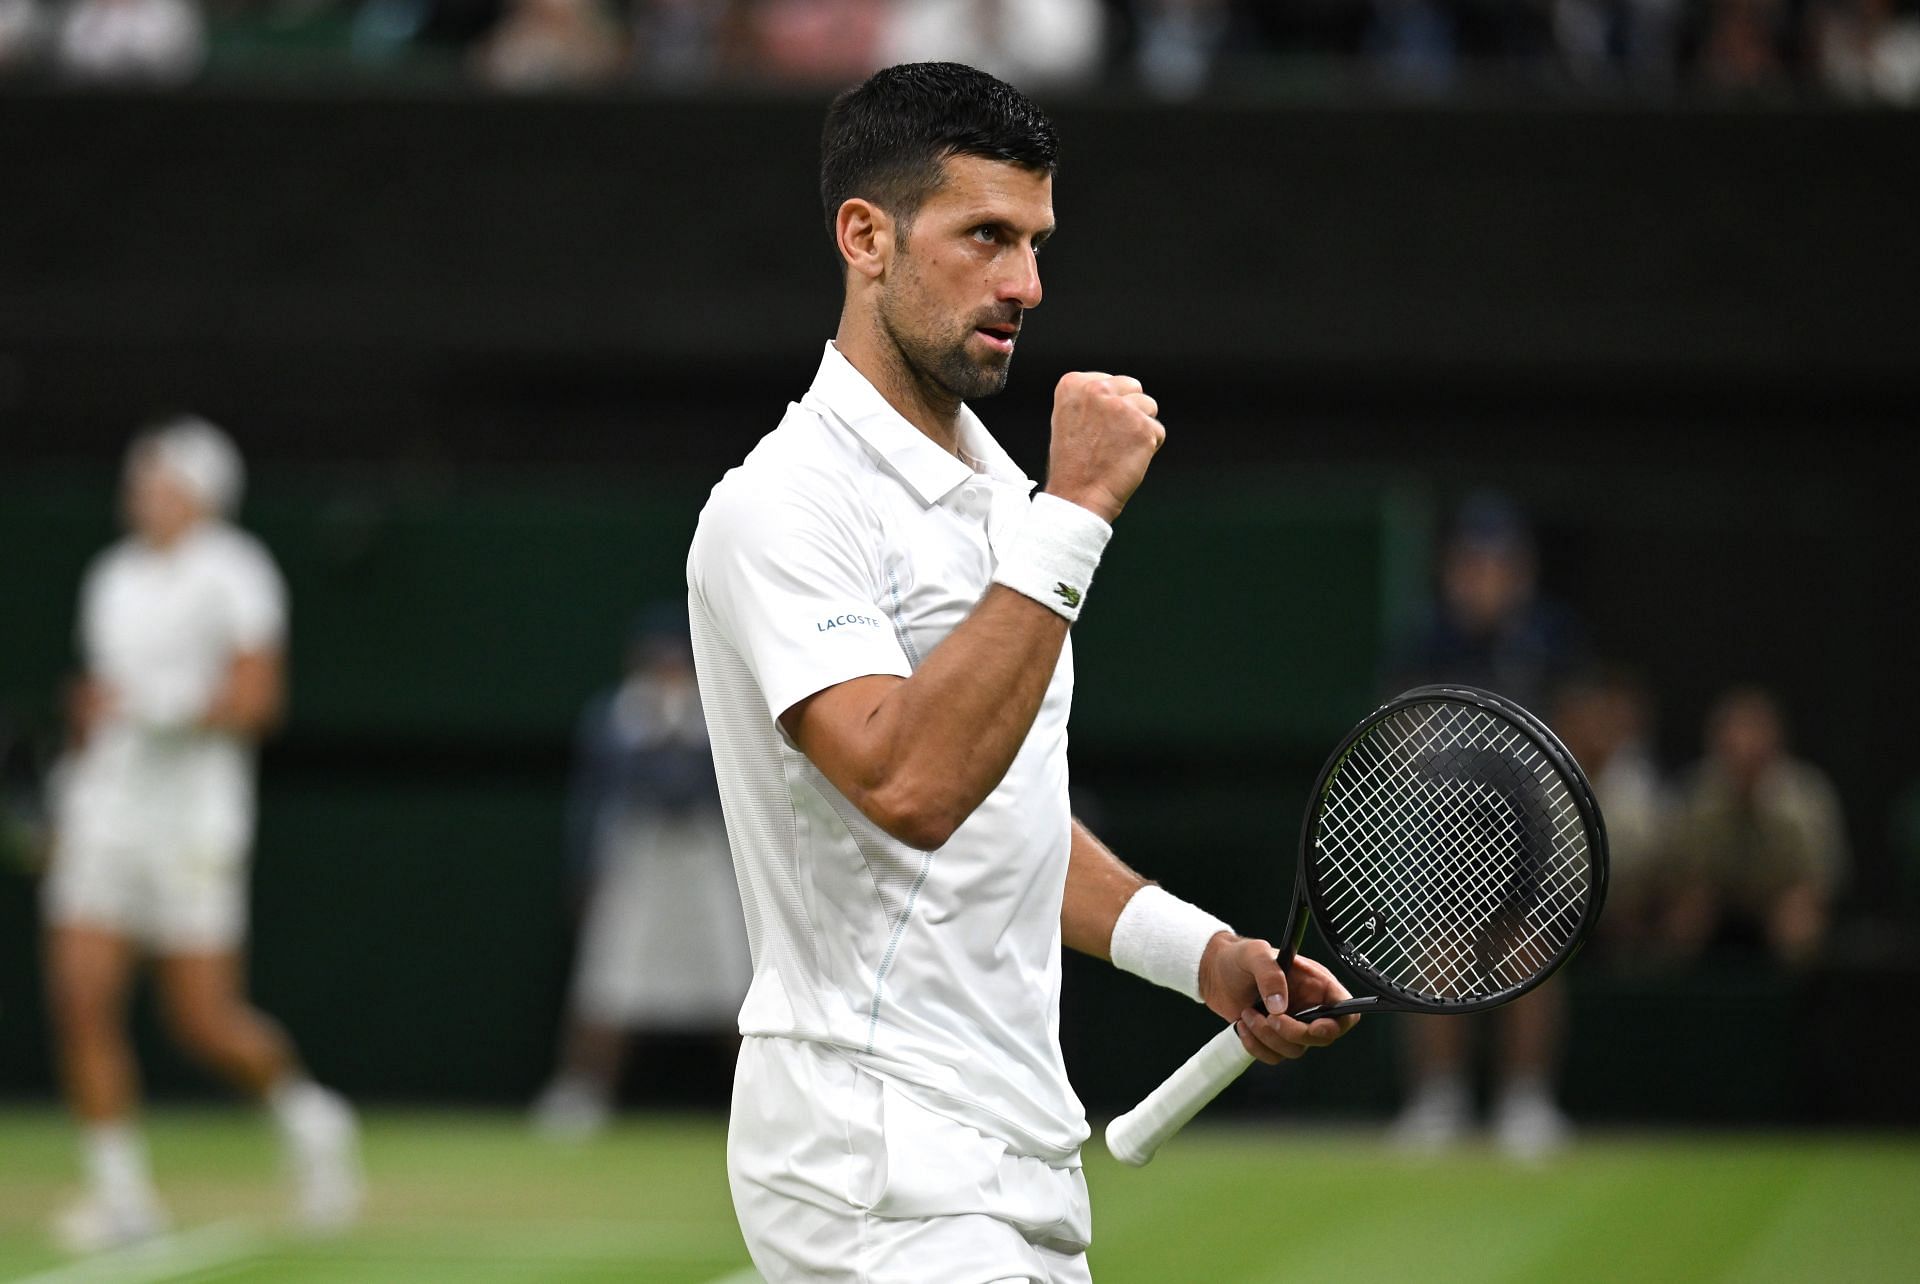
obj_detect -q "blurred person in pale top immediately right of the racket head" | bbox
[1551,670,1668,962]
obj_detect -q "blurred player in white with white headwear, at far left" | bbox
[44,418,359,1249]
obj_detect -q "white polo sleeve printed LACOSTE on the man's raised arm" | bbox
[695,479,914,720]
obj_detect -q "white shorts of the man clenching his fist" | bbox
[728,1038,1092,1284]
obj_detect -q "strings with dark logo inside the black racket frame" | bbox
[1309,702,1594,1002]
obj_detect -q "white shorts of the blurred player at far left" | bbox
[40,835,248,954]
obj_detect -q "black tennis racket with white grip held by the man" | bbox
[1106,685,1607,1165]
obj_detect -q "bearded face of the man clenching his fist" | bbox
[879,155,1054,401]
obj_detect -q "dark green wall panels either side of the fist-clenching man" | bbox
[0,474,1425,1098]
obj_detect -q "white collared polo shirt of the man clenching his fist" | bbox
[687,344,1087,1161]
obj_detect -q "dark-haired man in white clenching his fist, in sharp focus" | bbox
[687,63,1348,1284]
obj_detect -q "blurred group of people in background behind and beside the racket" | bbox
[1394,495,1851,969]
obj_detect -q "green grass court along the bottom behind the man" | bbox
[0,1111,1920,1284]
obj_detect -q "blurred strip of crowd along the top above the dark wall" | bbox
[0,0,1920,104]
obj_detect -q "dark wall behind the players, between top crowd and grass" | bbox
[0,90,1920,1123]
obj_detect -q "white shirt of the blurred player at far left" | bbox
[63,520,286,848]
